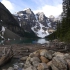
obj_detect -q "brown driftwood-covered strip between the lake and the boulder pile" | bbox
[0,42,70,58]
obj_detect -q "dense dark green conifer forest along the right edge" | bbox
[48,0,70,42]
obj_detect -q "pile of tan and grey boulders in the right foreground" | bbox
[2,49,70,70]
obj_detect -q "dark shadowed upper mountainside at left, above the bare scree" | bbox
[0,2,37,37]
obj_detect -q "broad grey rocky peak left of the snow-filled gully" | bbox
[14,9,36,31]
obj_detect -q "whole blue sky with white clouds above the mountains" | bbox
[0,0,63,17]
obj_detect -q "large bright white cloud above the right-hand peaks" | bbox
[34,4,62,17]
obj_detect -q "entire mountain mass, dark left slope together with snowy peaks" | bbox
[0,2,57,39]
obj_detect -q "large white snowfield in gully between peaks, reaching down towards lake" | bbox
[31,15,49,38]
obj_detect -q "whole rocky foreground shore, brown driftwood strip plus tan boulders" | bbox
[0,41,70,70]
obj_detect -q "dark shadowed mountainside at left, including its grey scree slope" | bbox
[0,2,38,39]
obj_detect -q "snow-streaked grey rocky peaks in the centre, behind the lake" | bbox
[13,8,57,38]
